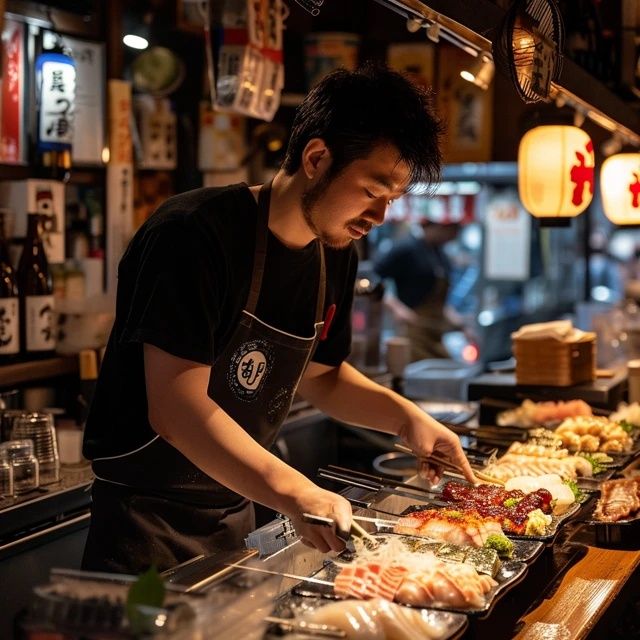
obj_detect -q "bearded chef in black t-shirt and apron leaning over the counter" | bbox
[83,68,473,572]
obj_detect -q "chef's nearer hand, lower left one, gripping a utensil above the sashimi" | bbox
[283,483,351,553]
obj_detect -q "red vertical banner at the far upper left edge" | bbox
[0,20,26,164]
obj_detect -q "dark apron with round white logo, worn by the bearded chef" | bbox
[83,184,326,573]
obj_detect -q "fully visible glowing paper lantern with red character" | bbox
[518,125,594,218]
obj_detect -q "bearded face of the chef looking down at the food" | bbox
[302,145,409,249]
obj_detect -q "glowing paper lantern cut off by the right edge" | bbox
[600,153,640,224]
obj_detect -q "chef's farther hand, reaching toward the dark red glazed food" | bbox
[398,407,478,484]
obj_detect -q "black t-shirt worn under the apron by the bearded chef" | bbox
[84,184,357,459]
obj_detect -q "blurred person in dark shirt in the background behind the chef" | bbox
[374,218,462,361]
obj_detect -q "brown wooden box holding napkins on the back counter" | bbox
[511,332,596,387]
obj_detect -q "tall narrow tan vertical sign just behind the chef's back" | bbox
[106,80,133,295]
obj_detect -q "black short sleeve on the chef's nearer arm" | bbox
[118,216,218,365]
